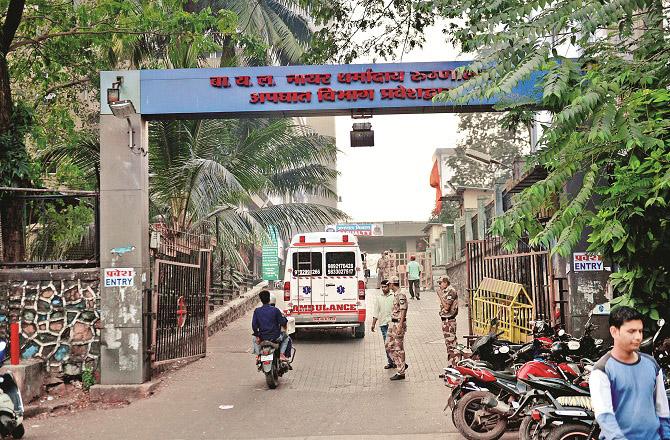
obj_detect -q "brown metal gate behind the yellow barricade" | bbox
[465,237,563,330]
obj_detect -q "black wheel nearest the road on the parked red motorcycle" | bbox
[452,391,507,440]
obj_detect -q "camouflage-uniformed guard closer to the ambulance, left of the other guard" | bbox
[386,276,408,380]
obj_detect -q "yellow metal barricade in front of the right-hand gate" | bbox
[470,278,535,343]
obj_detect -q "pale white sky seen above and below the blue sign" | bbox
[335,27,471,222]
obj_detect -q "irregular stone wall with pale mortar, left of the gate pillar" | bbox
[0,269,101,375]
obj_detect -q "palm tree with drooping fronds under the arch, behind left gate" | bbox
[149,119,345,261]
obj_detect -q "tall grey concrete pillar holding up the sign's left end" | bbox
[100,114,150,385]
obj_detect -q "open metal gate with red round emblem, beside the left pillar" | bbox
[150,228,211,368]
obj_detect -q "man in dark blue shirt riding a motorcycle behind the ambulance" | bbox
[251,290,290,361]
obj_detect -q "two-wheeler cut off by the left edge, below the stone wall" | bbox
[0,340,25,439]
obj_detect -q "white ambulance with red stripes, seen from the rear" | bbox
[284,232,365,338]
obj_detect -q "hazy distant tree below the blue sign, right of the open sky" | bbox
[447,113,530,188]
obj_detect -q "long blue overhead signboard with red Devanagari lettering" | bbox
[138,61,538,117]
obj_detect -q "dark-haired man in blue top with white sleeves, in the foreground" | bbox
[589,307,670,440]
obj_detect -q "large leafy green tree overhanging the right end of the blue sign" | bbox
[315,0,670,317]
